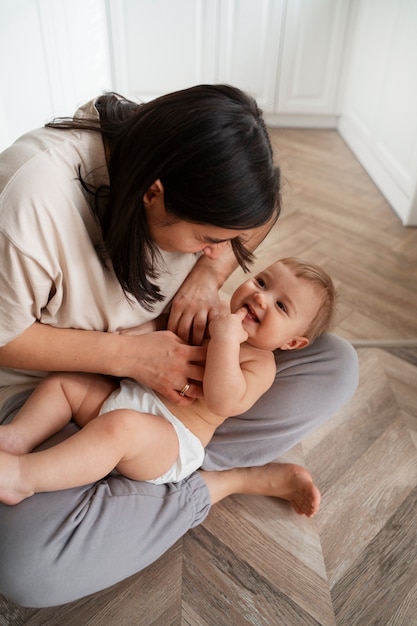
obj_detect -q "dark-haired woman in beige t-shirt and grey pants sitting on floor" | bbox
[0,86,356,606]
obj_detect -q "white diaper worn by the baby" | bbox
[100,378,204,485]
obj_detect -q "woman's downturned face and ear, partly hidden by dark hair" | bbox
[143,181,245,259]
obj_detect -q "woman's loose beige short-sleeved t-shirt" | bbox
[0,101,197,404]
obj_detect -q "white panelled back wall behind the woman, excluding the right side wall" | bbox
[0,0,351,144]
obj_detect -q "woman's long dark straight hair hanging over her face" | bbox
[48,85,280,308]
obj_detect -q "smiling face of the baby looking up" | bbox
[230,261,320,350]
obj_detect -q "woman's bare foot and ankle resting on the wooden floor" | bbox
[201,463,321,517]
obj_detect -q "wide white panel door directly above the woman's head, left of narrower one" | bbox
[107,0,217,101]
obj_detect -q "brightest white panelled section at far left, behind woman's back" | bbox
[0,0,112,150]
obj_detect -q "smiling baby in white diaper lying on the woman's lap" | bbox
[0,258,335,516]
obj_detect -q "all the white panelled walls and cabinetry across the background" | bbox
[0,0,417,225]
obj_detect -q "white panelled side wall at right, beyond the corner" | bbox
[338,0,417,225]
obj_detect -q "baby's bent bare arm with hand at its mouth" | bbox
[203,309,276,417]
